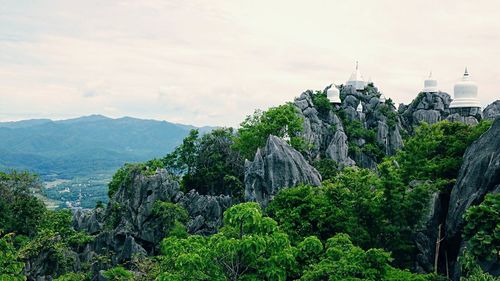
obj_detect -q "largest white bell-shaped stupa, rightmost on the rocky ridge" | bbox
[450,68,481,109]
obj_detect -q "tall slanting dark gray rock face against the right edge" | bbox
[446,117,500,279]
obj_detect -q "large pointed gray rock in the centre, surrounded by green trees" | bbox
[245,135,321,206]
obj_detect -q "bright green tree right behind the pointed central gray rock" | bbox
[234,103,306,159]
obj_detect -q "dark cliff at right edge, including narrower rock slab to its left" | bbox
[415,117,500,280]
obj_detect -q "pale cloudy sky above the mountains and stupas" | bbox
[0,0,500,126]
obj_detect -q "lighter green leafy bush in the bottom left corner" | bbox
[0,231,26,281]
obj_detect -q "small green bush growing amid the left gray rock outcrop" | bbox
[152,201,189,237]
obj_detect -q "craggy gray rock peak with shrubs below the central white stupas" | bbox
[294,86,404,169]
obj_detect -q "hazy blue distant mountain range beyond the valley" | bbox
[0,115,213,180]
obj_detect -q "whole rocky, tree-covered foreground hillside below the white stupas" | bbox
[0,84,500,281]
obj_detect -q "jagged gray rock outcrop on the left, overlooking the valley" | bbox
[73,170,233,272]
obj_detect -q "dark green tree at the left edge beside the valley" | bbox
[0,171,45,236]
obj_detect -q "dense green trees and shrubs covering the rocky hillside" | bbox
[0,103,500,281]
